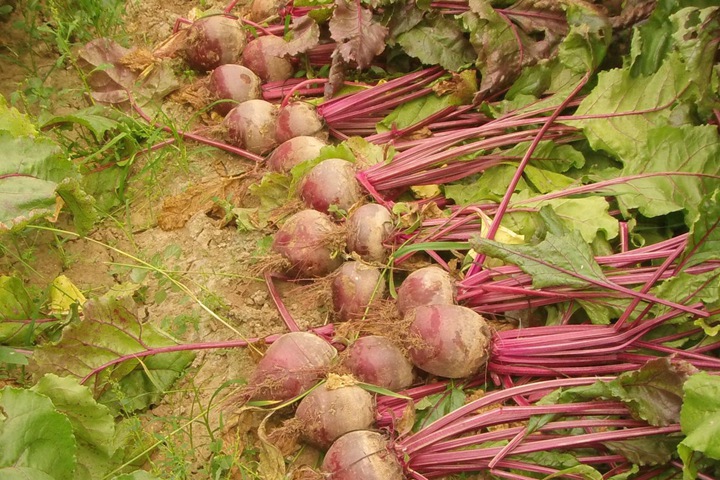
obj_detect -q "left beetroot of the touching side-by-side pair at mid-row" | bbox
[272,210,342,277]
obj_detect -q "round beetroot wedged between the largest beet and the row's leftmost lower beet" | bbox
[343,335,413,391]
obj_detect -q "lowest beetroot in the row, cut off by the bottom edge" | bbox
[322,430,405,480]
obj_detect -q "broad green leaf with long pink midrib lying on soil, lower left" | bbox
[31,295,194,409]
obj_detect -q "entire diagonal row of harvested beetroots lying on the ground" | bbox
[175,16,504,479]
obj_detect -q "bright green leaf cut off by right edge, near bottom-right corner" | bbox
[680,372,720,460]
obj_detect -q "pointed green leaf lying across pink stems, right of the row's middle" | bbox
[470,207,607,288]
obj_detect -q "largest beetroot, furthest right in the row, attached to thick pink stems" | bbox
[408,305,491,378]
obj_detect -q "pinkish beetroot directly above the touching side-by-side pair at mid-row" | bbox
[298,158,362,213]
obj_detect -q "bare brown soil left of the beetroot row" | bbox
[0,0,327,479]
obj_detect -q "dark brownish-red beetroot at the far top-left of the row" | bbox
[185,15,247,72]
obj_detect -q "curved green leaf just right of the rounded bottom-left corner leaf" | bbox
[31,374,115,480]
